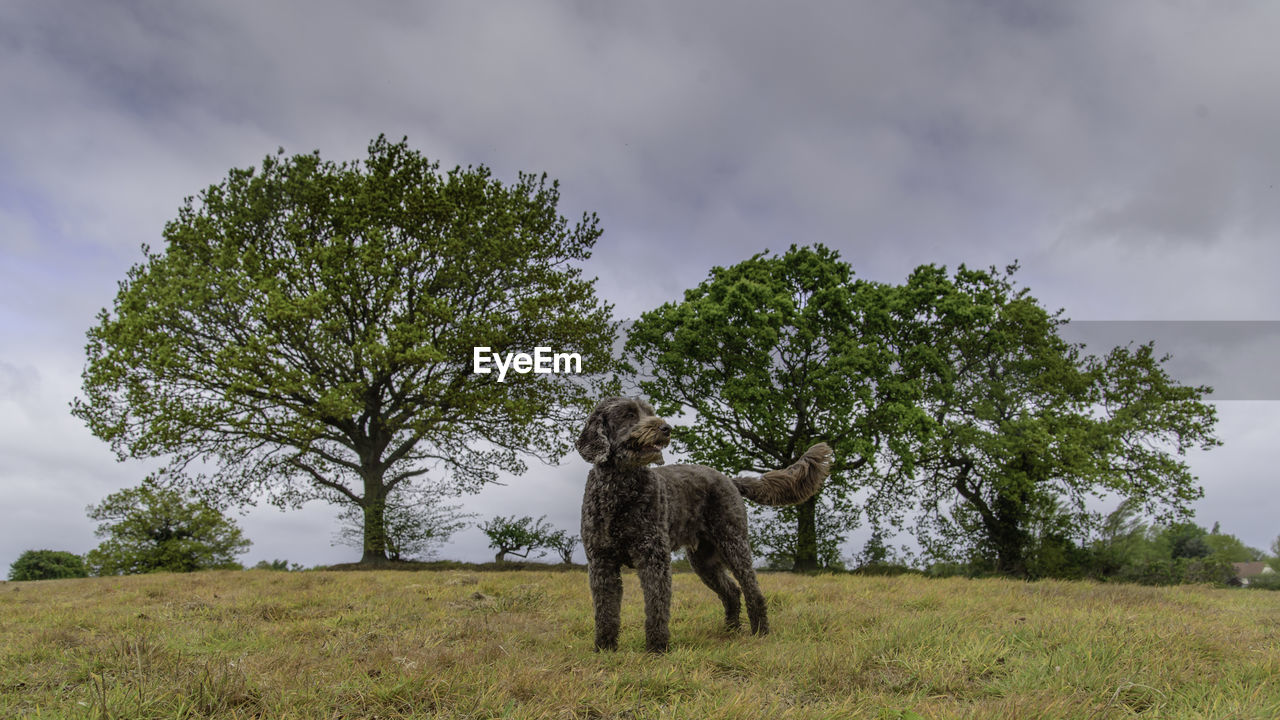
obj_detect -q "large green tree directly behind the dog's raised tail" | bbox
[625,245,920,570]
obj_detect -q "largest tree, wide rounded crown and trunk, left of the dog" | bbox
[73,137,614,562]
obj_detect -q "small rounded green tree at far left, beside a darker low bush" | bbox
[86,482,251,575]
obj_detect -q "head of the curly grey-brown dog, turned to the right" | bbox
[577,397,671,466]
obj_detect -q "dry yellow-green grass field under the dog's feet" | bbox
[0,570,1280,720]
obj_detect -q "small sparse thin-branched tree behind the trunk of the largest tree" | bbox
[334,484,475,562]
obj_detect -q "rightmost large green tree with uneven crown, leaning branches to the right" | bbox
[873,260,1219,575]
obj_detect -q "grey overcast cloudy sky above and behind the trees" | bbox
[0,0,1280,569]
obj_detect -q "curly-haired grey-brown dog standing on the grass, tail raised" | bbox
[577,397,831,652]
